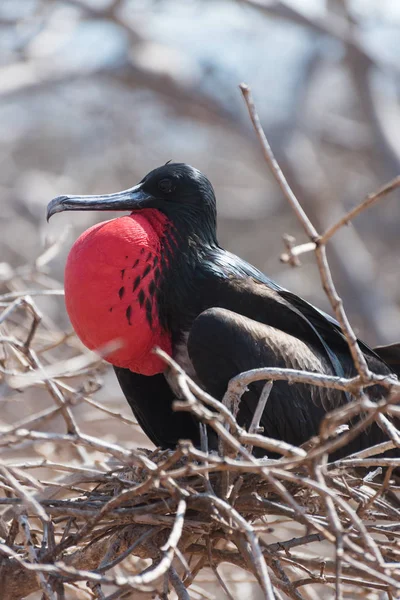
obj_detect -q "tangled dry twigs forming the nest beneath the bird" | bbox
[0,332,400,600]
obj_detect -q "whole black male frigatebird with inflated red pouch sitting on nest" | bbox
[47,163,398,452]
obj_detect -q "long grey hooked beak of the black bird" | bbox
[46,183,152,221]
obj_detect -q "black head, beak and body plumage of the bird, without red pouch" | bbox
[49,164,400,455]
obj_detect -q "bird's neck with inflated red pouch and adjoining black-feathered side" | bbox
[65,209,216,375]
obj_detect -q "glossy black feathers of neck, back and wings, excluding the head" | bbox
[114,164,391,450]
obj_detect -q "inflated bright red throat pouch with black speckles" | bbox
[65,209,171,375]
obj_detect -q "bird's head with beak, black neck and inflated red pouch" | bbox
[47,163,217,375]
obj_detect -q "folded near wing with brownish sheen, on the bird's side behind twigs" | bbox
[188,308,394,458]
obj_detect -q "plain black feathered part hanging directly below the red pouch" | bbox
[114,367,200,448]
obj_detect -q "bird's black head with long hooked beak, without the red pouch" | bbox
[47,163,216,244]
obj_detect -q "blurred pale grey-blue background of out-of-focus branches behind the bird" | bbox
[0,0,400,596]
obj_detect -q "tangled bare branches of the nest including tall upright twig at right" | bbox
[0,88,400,600]
